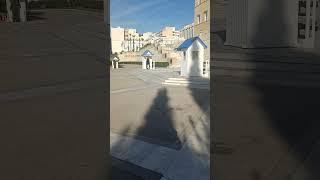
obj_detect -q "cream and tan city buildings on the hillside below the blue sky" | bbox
[111,0,210,72]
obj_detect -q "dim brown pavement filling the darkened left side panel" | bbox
[0,10,107,180]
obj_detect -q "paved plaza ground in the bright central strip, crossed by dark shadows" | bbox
[110,65,210,180]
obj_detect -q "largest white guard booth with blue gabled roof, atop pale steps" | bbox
[176,37,209,77]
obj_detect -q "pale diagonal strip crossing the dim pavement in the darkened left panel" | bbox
[0,78,105,102]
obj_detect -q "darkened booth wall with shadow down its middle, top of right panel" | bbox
[226,0,298,48]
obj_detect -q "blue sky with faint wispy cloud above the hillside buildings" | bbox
[110,0,194,33]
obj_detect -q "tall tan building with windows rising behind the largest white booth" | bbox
[193,0,210,67]
